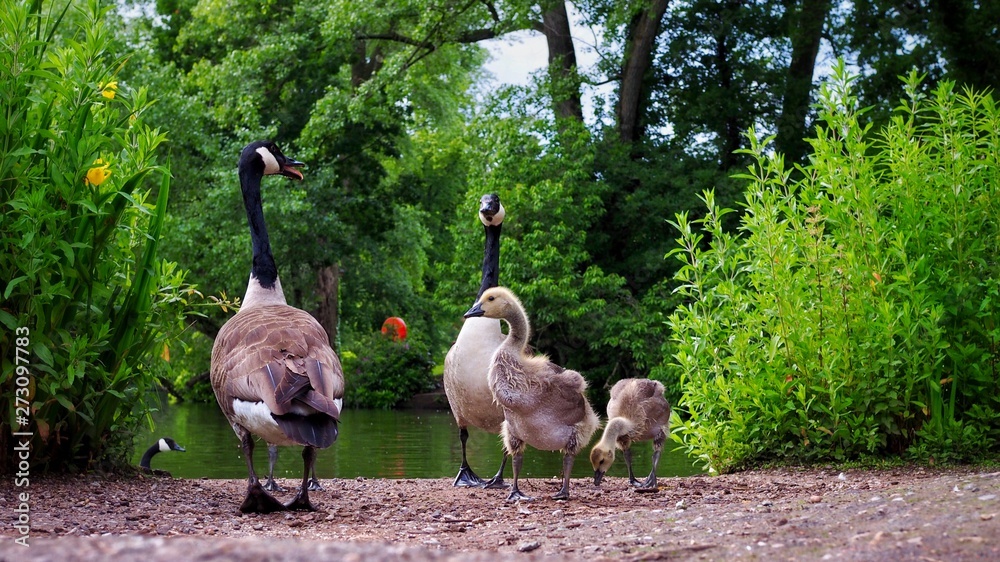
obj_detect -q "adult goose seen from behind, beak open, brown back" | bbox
[212,141,344,513]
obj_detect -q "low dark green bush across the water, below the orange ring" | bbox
[342,332,434,410]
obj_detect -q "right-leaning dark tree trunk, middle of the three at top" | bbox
[617,0,667,143]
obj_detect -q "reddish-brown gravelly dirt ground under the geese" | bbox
[0,468,1000,562]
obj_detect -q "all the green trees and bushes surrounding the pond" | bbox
[0,0,1000,471]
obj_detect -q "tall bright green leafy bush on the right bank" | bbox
[670,61,1000,471]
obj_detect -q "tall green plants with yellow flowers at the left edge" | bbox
[0,2,198,470]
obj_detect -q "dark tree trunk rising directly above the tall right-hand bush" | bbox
[775,0,831,163]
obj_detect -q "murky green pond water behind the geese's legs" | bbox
[135,403,699,479]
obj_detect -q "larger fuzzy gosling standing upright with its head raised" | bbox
[465,287,599,501]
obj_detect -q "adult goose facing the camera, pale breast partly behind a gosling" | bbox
[444,194,507,488]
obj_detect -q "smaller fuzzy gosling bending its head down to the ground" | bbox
[590,379,670,488]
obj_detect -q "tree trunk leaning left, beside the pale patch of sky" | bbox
[539,0,583,121]
